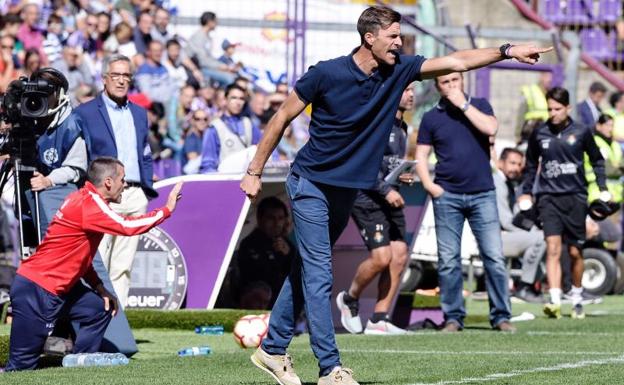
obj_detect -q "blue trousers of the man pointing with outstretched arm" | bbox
[262,173,357,376]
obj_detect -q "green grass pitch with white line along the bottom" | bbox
[0,296,624,385]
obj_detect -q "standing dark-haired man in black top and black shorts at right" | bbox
[518,87,611,319]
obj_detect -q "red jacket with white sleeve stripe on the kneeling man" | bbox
[17,182,171,295]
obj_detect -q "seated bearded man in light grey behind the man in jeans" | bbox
[493,148,546,303]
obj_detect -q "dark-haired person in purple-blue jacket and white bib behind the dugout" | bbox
[200,84,261,173]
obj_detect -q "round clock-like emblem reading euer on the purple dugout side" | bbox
[127,227,187,310]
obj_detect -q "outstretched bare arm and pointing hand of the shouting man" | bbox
[420,44,553,79]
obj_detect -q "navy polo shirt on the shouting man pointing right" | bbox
[293,51,425,189]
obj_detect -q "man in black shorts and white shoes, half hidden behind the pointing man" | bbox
[336,85,414,335]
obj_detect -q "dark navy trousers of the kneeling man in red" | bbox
[6,275,111,371]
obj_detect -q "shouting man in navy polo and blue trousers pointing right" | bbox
[241,6,550,385]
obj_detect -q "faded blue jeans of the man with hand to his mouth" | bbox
[433,190,511,327]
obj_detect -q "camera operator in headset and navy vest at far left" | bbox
[20,67,87,238]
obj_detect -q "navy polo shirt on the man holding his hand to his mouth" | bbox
[418,98,494,194]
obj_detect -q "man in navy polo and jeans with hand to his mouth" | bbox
[416,72,515,332]
